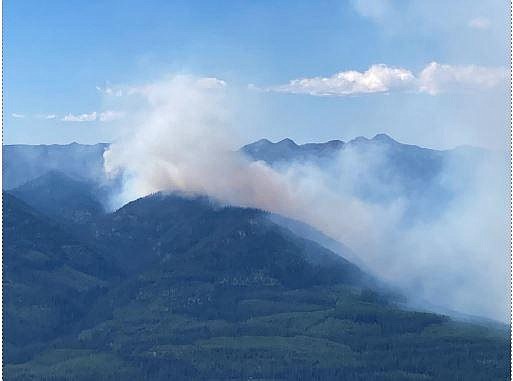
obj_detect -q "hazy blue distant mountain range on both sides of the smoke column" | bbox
[3,134,486,230]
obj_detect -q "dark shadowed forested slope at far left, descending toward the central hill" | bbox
[3,193,120,361]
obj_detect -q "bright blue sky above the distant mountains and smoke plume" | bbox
[4,0,509,148]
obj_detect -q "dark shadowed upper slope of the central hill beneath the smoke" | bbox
[87,194,365,284]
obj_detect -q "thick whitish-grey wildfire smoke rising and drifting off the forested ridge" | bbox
[104,76,509,321]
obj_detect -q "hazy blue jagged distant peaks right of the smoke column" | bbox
[241,134,487,223]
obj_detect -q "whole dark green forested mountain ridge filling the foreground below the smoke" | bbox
[4,189,509,380]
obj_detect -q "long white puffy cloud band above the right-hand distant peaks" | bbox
[266,62,506,96]
